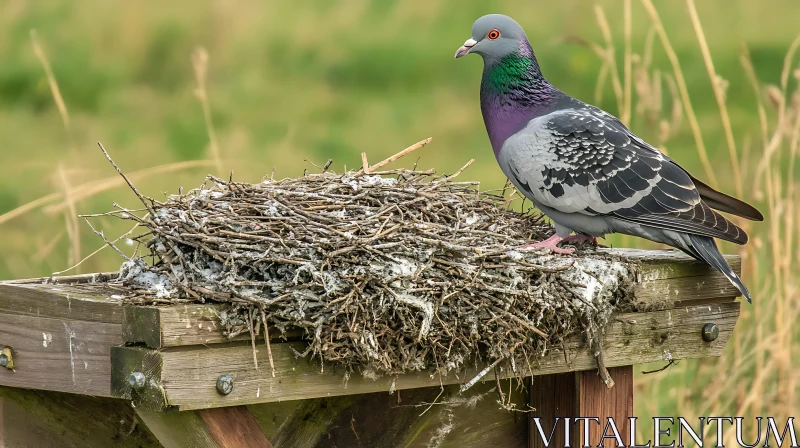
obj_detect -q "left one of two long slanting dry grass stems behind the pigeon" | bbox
[641,0,719,188]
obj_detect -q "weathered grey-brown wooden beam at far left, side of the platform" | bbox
[0,283,122,397]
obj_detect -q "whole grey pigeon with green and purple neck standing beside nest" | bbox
[455,14,764,302]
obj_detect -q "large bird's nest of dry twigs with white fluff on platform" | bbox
[87,141,630,384]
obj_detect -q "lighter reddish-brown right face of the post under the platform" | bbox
[573,366,635,448]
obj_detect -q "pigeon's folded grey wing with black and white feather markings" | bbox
[501,105,747,244]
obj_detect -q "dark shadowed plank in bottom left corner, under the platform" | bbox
[0,387,161,448]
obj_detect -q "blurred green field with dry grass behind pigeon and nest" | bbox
[0,0,800,440]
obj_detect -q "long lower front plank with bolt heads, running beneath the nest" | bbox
[112,302,739,410]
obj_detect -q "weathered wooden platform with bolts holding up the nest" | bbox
[0,250,740,447]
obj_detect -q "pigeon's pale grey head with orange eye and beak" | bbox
[456,14,528,60]
